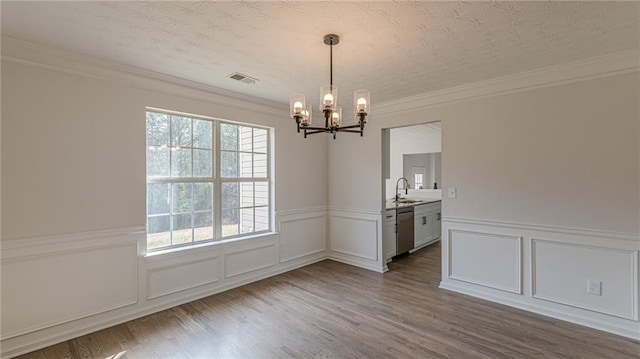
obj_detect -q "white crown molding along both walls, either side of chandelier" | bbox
[2,36,640,118]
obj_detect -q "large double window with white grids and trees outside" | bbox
[146,112,271,251]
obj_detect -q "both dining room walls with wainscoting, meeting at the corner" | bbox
[0,39,640,356]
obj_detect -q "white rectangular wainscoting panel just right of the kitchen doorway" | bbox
[449,230,522,294]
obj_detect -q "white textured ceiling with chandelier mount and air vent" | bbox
[0,1,640,109]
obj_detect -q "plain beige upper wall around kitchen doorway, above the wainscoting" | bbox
[329,73,640,234]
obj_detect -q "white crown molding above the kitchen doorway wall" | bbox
[372,50,640,116]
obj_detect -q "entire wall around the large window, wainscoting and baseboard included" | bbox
[1,38,328,357]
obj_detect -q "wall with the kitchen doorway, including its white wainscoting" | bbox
[329,54,640,339]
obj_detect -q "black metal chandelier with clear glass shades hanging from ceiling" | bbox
[290,34,371,140]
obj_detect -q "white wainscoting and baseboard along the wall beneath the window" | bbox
[0,208,328,358]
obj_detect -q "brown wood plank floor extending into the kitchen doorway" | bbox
[15,244,640,358]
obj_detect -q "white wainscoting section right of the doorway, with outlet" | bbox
[440,217,640,340]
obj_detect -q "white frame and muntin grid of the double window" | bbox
[145,107,274,253]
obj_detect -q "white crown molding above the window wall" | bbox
[2,36,289,118]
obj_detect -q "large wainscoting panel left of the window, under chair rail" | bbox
[2,238,138,340]
